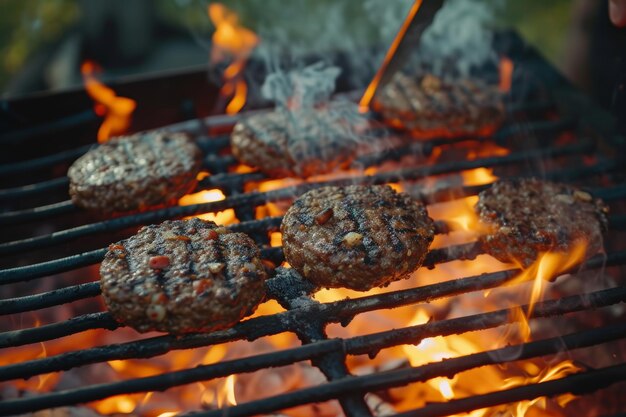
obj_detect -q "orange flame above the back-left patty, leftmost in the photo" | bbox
[80,61,137,143]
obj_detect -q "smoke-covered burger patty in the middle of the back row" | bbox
[231,107,360,178]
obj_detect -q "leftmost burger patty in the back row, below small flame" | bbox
[67,132,202,213]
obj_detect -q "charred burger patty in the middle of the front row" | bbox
[281,186,434,291]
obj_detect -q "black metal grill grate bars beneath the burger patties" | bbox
[0,31,626,417]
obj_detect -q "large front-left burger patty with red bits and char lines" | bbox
[100,219,267,334]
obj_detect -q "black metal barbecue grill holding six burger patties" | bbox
[0,32,626,416]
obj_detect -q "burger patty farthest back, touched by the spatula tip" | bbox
[372,73,504,139]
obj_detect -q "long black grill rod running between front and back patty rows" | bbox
[0,141,594,255]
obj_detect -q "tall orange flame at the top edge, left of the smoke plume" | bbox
[208,3,259,114]
